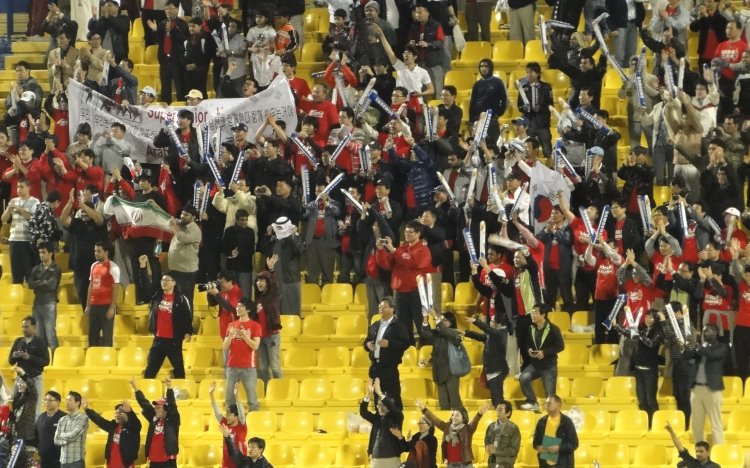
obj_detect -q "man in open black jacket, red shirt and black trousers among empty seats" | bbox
[141,268,193,379]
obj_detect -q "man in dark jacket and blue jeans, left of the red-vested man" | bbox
[29,242,62,355]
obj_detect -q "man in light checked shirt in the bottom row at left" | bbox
[55,392,89,468]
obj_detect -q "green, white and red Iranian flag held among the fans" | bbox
[104,196,172,241]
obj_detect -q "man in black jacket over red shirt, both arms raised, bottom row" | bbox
[130,379,180,468]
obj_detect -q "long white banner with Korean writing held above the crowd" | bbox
[68,75,297,164]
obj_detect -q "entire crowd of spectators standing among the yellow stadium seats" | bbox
[0,0,750,468]
